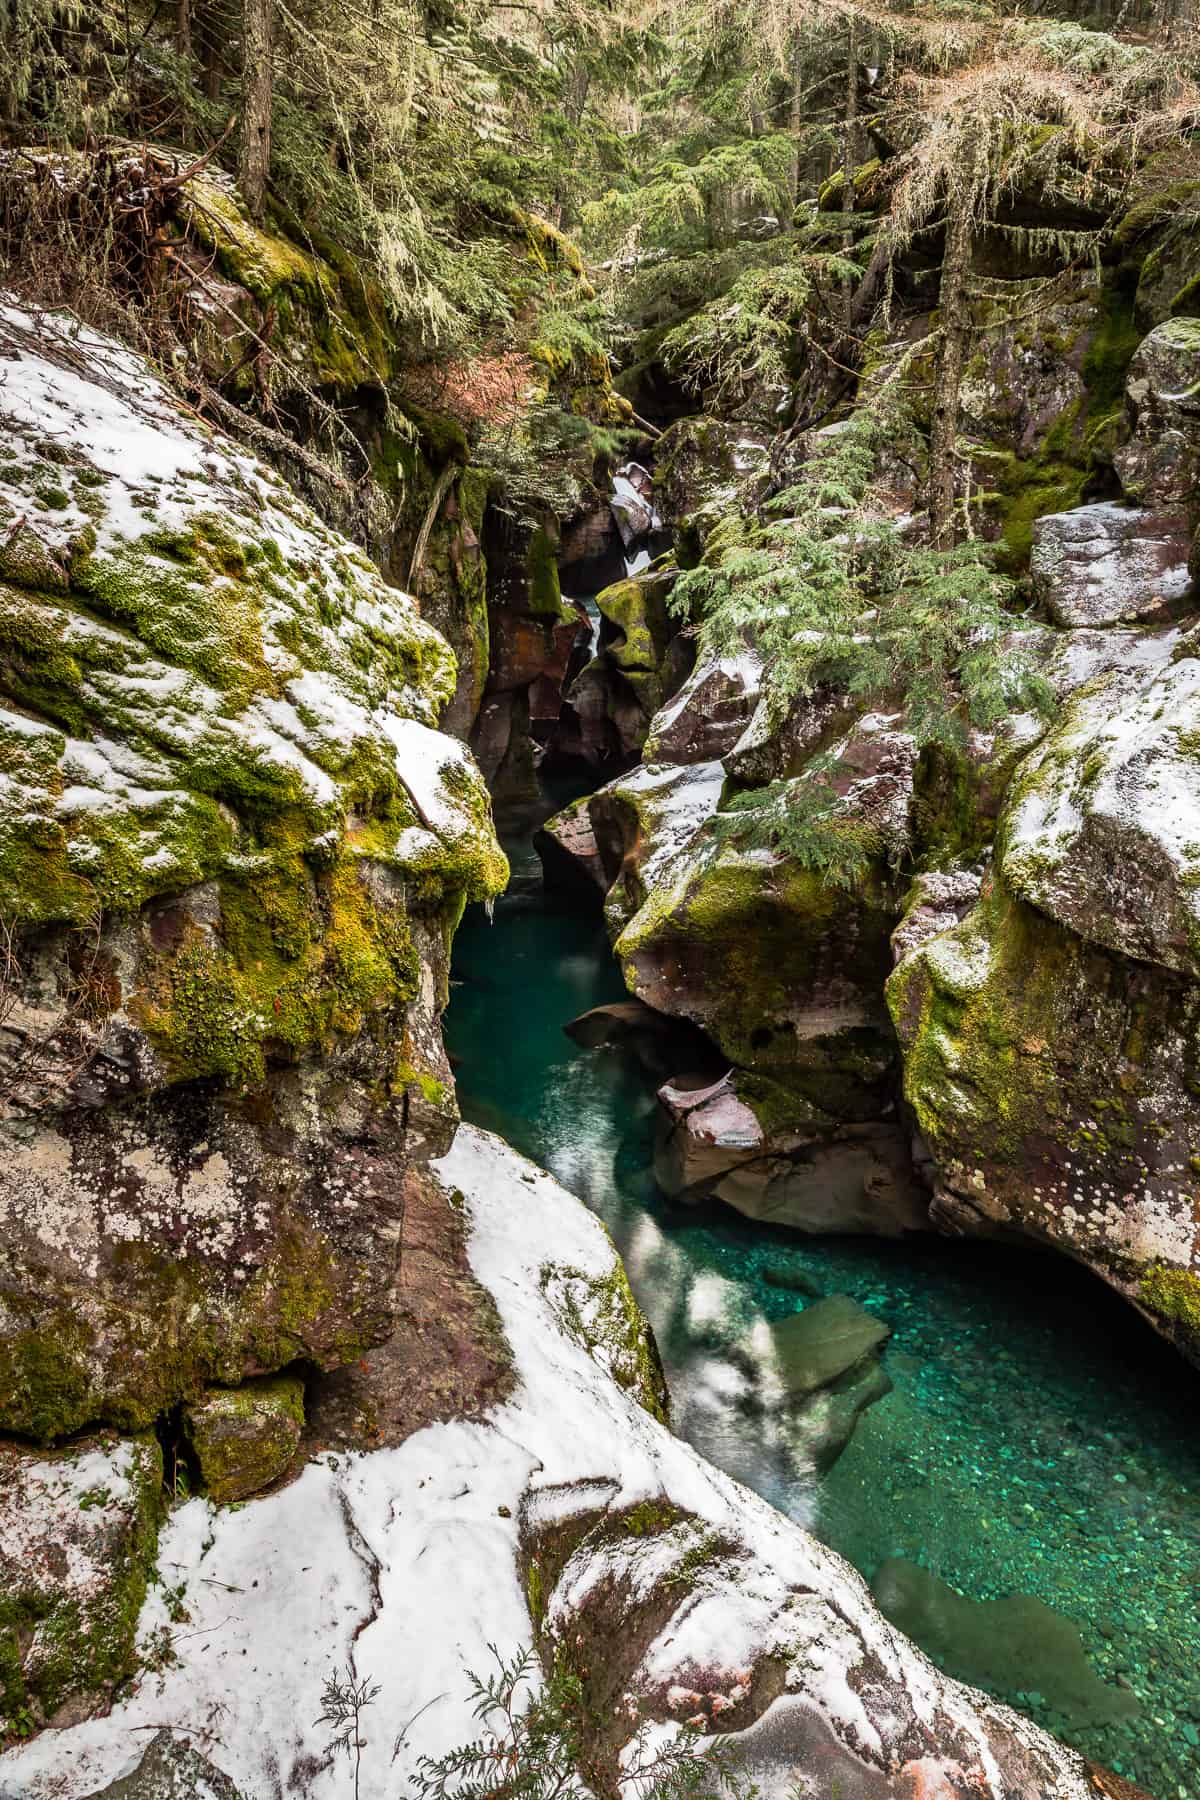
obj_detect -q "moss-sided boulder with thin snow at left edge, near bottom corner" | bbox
[0,1436,162,1742]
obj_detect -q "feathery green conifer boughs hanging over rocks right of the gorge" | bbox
[669,376,1049,743]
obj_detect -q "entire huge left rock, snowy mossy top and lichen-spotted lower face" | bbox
[0,306,506,1438]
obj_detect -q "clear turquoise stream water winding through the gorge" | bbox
[446,795,1200,1800]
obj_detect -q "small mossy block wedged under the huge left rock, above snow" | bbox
[184,1375,304,1507]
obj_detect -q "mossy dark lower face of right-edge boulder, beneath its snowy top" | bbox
[887,878,1200,1359]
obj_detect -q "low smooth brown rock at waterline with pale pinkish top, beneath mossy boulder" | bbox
[655,1069,928,1237]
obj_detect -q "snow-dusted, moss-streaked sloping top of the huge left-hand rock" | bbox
[0,299,495,904]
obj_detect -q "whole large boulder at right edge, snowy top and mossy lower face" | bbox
[889,639,1200,1357]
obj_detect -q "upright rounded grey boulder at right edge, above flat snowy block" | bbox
[1114,319,1200,509]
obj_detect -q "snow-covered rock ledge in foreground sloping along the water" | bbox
[0,1127,1088,1800]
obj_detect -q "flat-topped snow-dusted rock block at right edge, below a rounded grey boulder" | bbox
[1029,500,1191,626]
